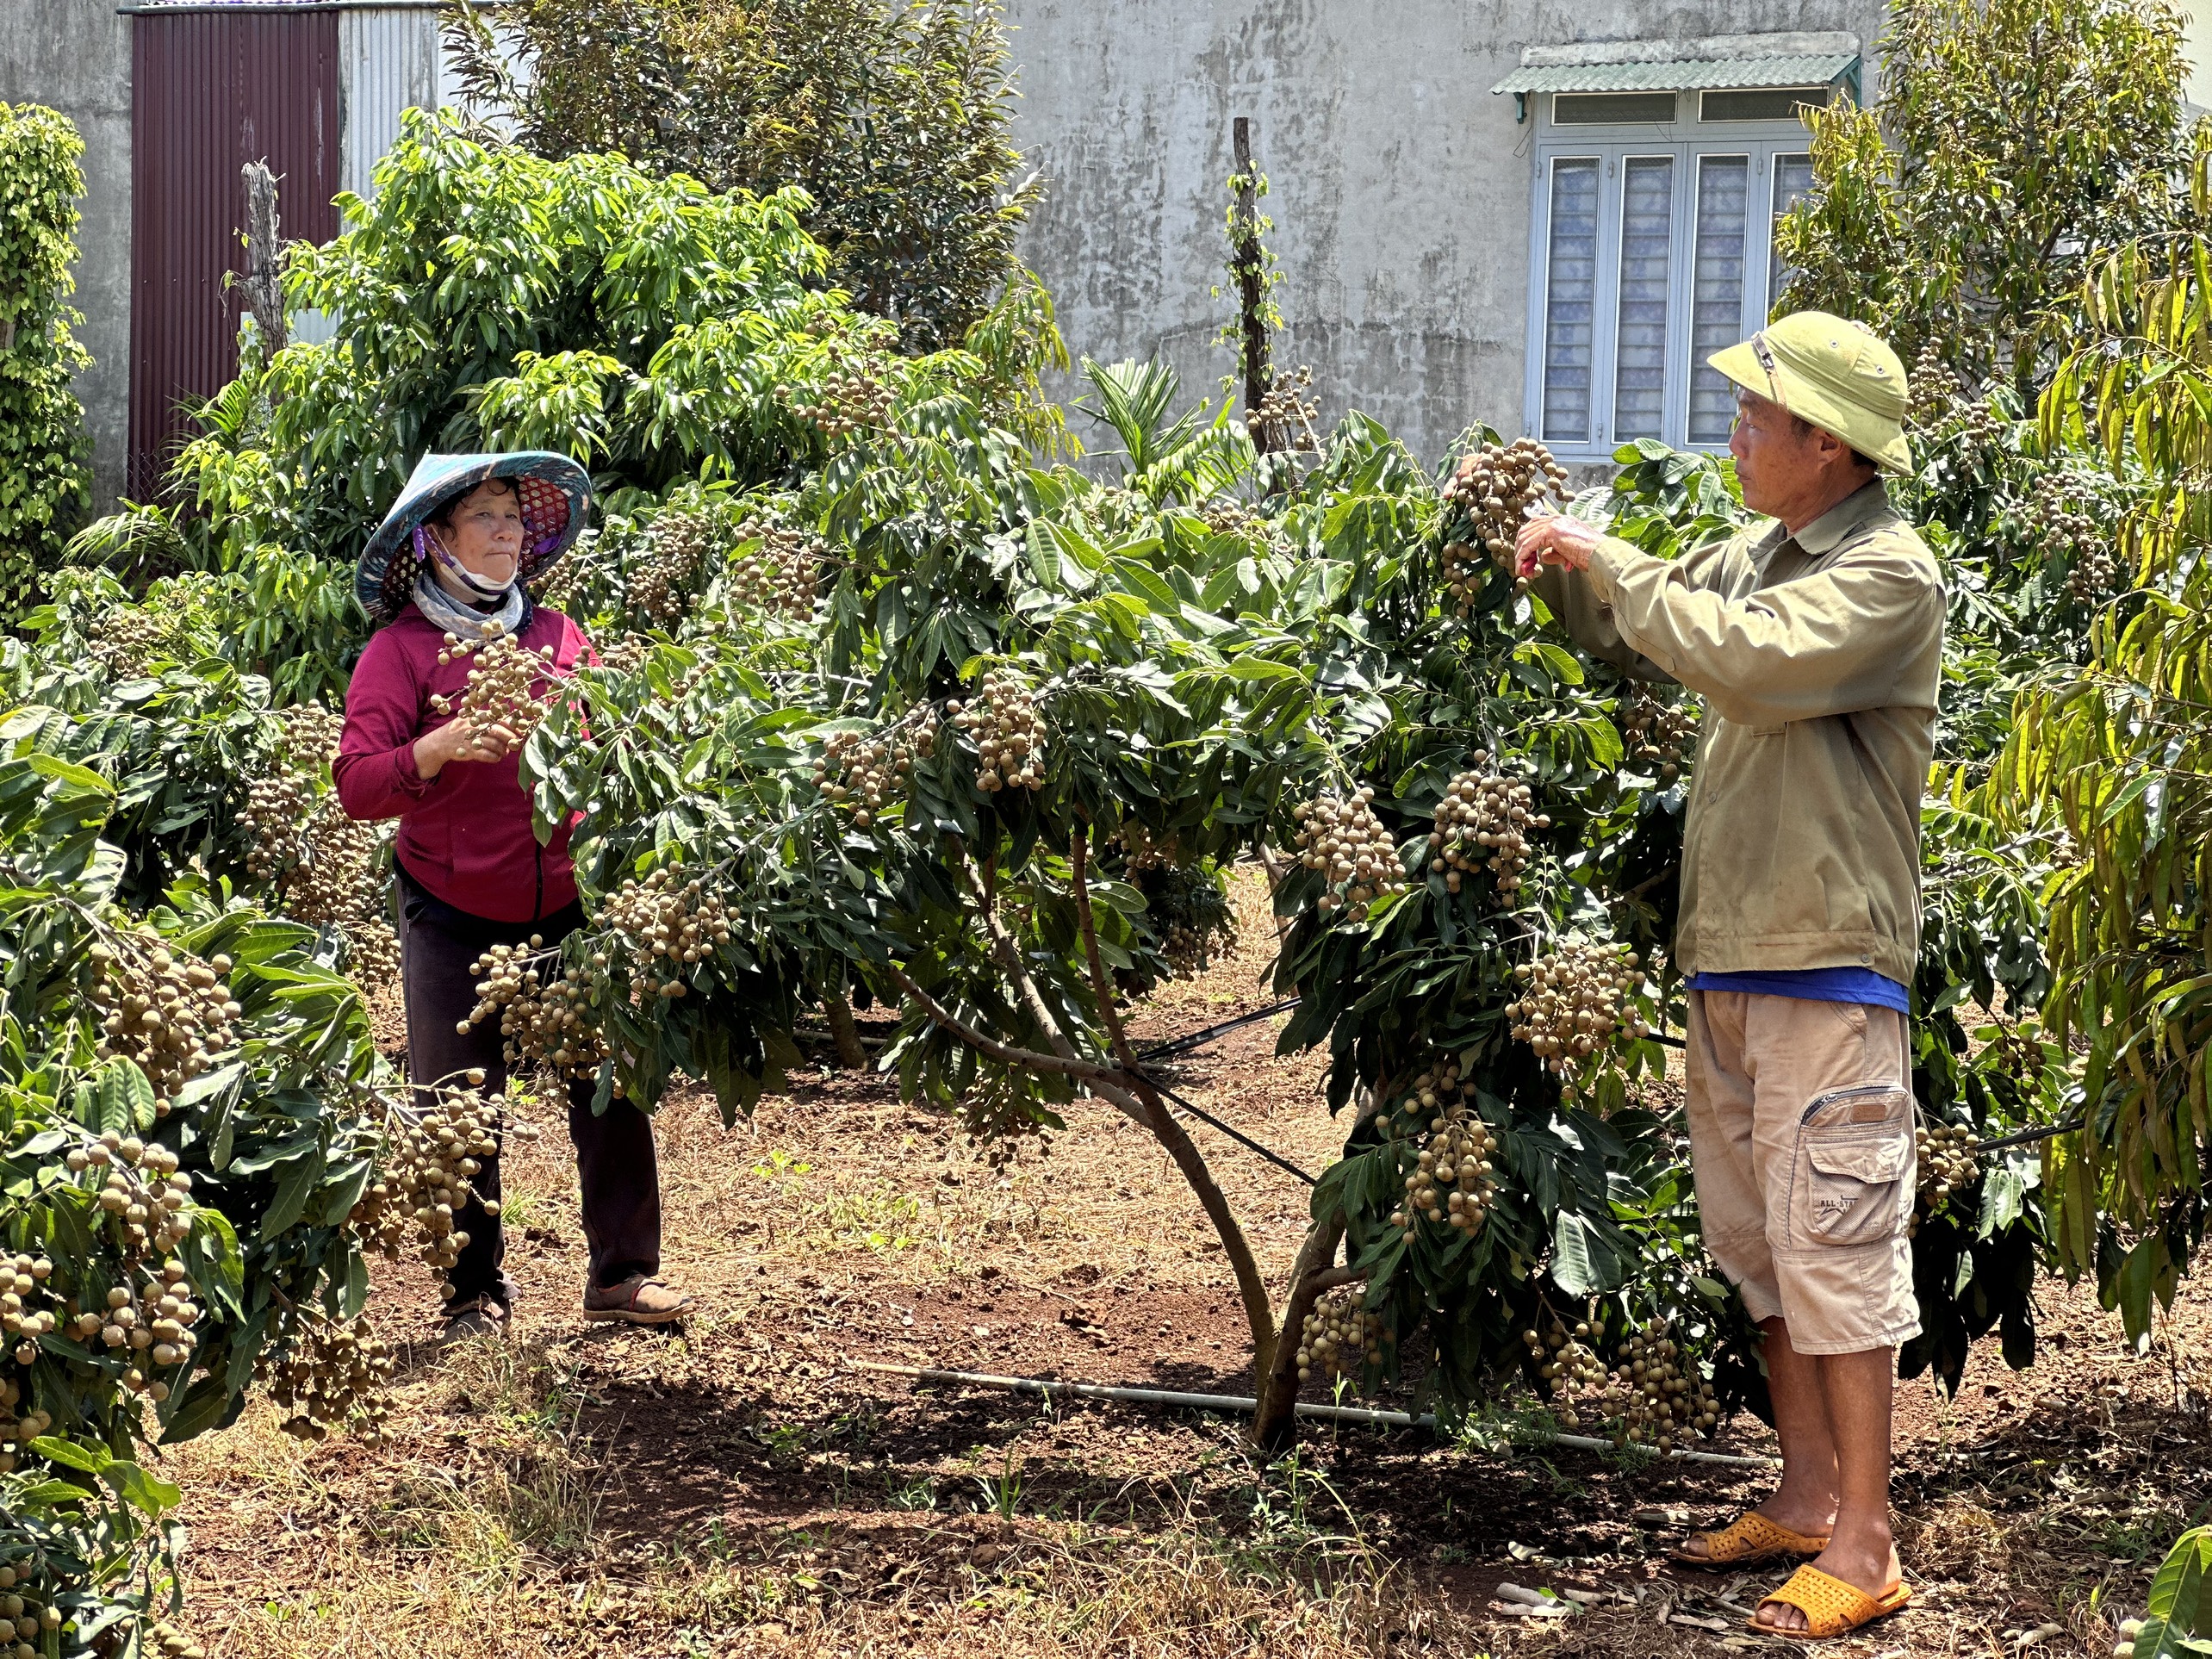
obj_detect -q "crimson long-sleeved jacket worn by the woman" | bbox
[330,606,597,923]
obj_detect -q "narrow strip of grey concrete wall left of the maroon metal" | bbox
[0,0,131,511]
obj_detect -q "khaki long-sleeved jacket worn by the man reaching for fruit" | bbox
[1535,480,1944,985]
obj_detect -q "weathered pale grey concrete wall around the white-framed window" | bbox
[1006,0,1887,460]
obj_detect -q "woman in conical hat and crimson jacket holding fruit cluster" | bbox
[332,453,688,1339]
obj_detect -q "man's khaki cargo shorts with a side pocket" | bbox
[1687,991,1920,1354]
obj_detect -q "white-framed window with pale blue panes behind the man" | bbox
[1528,89,1827,460]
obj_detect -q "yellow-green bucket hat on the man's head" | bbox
[1707,312,1913,474]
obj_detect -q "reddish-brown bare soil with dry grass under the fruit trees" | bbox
[168,887,2212,1659]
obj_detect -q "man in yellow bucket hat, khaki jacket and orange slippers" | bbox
[1515,312,1944,1637]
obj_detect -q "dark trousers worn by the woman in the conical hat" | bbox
[401,869,662,1305]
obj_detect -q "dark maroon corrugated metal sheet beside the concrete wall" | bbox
[126,0,340,500]
